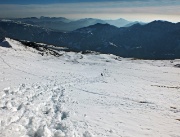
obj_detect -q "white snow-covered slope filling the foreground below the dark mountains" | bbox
[0,38,180,137]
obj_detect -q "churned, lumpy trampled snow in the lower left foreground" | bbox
[0,84,78,137]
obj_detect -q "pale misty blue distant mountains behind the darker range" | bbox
[5,16,137,32]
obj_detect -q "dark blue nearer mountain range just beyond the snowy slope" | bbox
[0,18,180,59]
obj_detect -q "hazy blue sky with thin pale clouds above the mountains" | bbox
[0,0,180,22]
